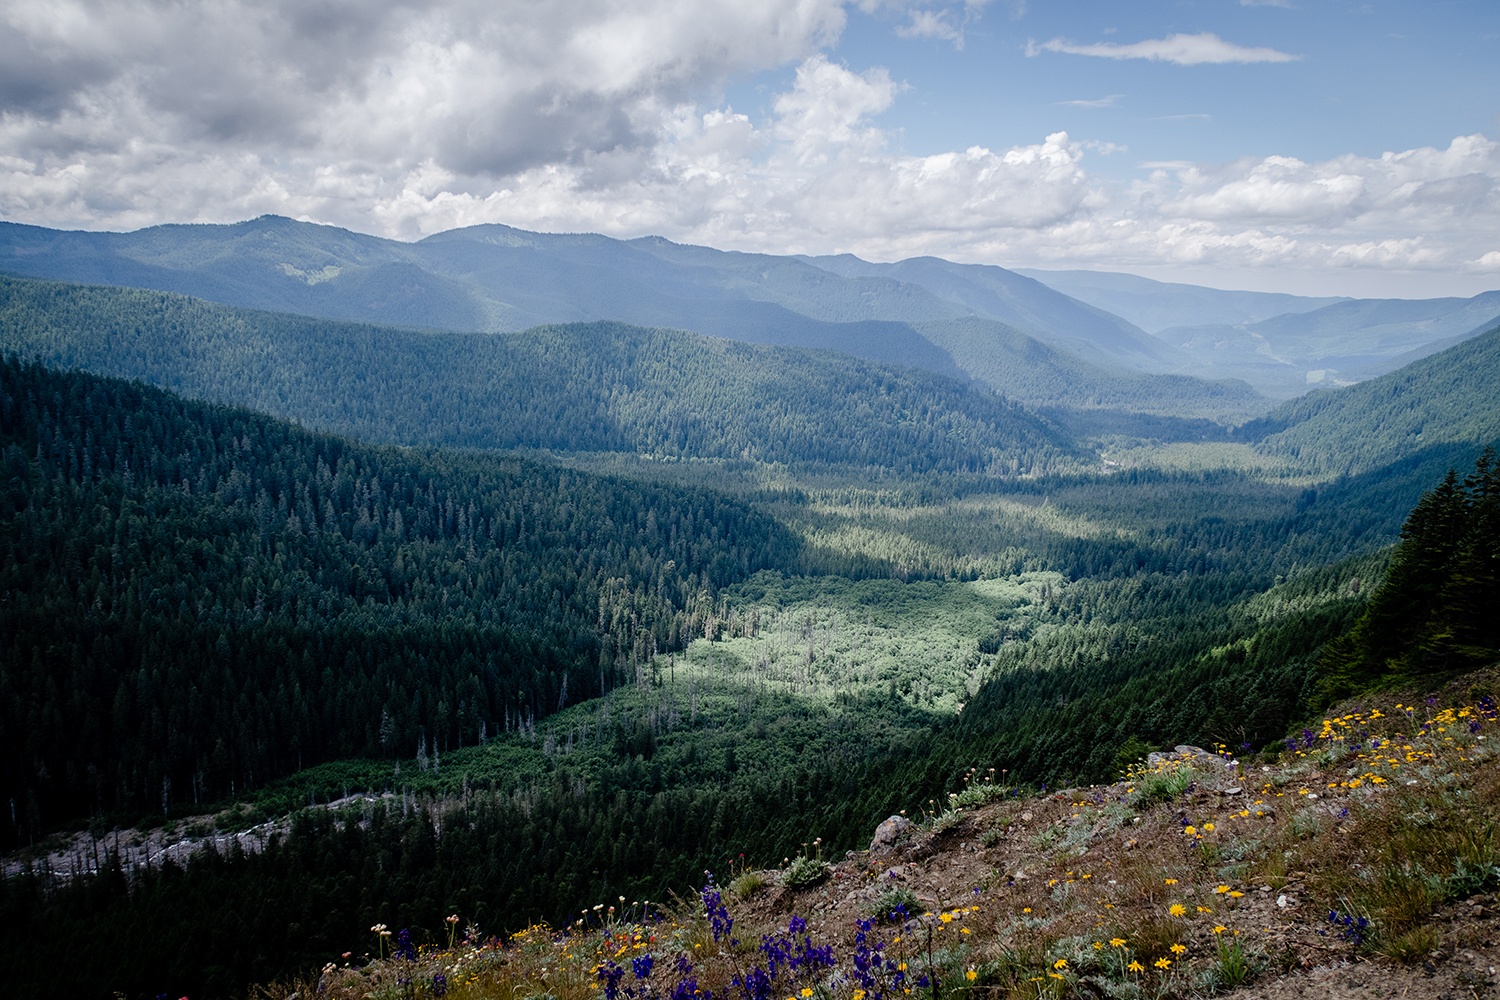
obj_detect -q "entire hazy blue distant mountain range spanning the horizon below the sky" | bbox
[0,216,1500,423]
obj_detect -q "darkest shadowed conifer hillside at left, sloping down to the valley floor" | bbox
[0,361,798,843]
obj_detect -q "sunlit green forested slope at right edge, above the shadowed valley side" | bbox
[1242,327,1500,475]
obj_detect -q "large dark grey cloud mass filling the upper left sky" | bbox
[0,0,845,183]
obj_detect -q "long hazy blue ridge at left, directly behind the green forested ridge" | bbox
[0,216,1263,418]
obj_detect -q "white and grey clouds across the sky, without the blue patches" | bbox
[0,0,1500,296]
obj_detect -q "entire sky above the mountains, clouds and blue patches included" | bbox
[0,0,1500,297]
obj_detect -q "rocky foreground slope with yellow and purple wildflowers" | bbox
[263,669,1500,1000]
